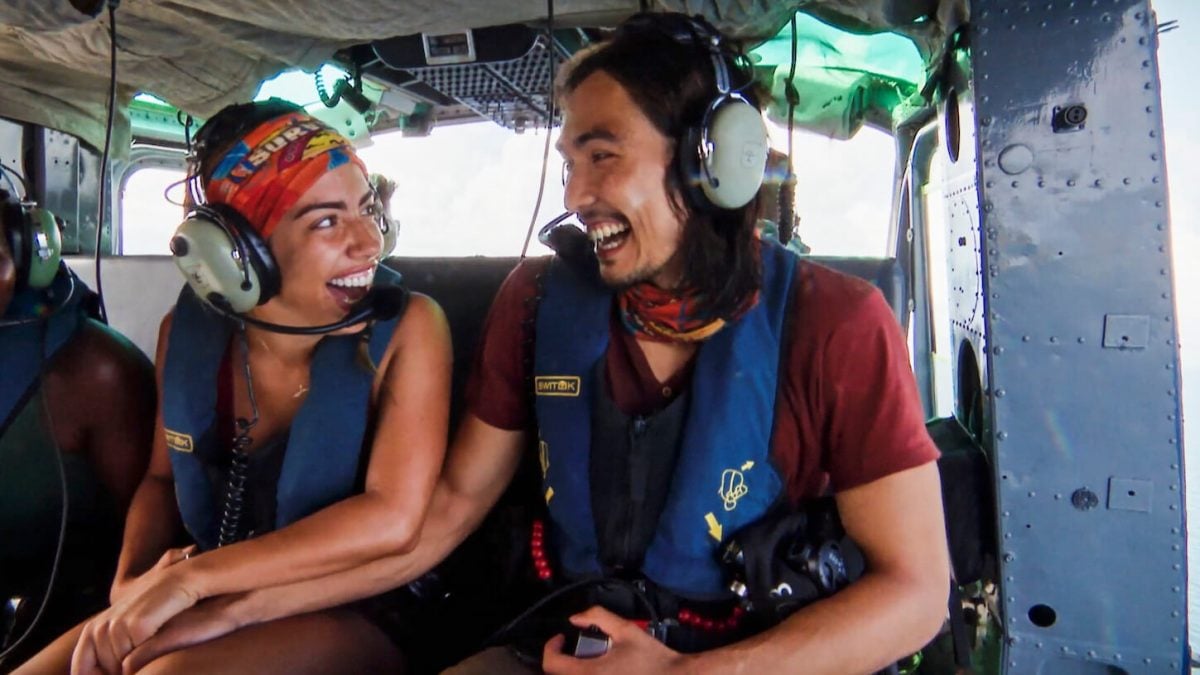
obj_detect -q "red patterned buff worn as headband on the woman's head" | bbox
[205,113,367,239]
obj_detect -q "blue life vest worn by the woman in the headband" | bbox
[162,267,401,550]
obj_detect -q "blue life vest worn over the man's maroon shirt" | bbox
[534,241,797,599]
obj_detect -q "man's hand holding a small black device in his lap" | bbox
[541,607,689,675]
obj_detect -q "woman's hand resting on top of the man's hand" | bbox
[71,563,200,675]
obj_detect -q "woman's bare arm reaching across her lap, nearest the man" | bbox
[72,295,451,673]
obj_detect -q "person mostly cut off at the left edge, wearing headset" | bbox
[0,184,155,661]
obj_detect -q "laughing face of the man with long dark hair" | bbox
[558,71,683,288]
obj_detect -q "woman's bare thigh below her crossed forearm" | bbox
[138,609,403,675]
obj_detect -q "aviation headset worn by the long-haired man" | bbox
[617,13,767,211]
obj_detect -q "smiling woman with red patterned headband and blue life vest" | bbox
[19,101,451,674]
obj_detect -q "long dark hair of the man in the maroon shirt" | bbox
[557,13,762,318]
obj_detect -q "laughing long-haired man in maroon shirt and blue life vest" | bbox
[121,14,949,674]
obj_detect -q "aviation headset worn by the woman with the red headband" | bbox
[170,100,396,315]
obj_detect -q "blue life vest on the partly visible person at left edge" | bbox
[0,263,89,434]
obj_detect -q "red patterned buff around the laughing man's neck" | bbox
[618,281,758,342]
